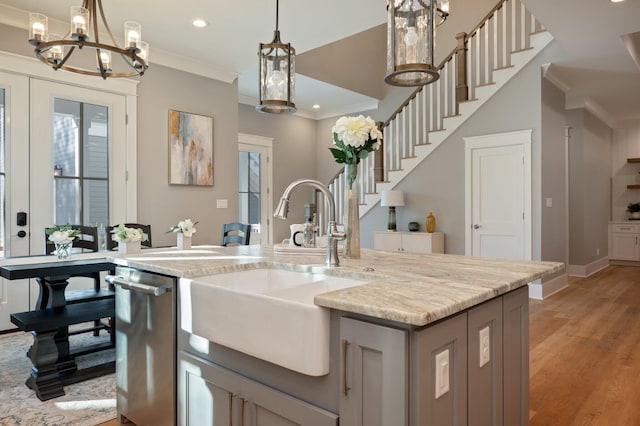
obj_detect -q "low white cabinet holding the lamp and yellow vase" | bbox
[373,231,444,253]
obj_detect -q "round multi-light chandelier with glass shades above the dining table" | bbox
[29,0,149,80]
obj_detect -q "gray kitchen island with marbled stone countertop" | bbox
[111,246,563,425]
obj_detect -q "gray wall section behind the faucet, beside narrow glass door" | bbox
[234,104,318,243]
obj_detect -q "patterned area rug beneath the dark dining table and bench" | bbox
[0,331,116,426]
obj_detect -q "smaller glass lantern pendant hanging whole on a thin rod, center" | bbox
[256,0,297,114]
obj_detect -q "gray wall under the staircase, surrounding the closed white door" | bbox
[361,42,561,259]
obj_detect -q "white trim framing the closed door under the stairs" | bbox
[463,129,533,260]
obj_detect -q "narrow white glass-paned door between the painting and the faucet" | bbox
[238,133,273,245]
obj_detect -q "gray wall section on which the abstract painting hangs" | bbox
[138,64,238,246]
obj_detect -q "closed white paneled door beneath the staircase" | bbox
[465,131,531,259]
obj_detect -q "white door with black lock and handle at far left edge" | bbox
[0,72,30,330]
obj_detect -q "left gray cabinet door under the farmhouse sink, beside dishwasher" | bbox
[178,351,238,426]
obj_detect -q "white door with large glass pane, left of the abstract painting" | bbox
[30,80,126,254]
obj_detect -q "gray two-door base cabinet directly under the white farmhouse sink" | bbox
[178,351,338,426]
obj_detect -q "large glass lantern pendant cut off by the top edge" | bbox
[384,0,449,86]
